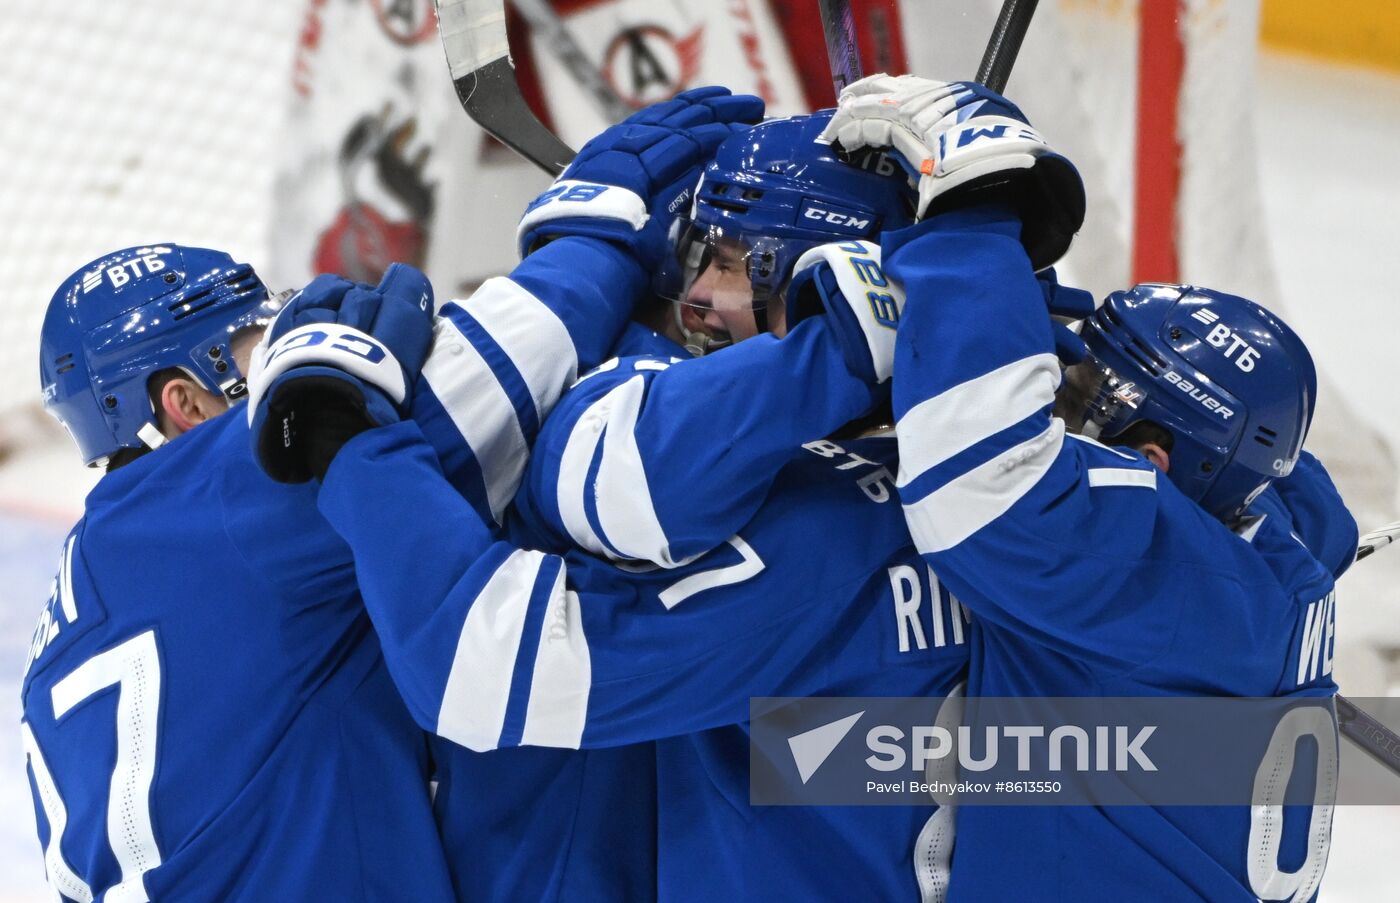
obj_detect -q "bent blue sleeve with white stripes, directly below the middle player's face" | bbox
[518,318,882,567]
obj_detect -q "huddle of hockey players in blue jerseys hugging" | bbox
[22,76,1357,902]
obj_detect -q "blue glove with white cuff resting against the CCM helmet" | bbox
[515,87,763,273]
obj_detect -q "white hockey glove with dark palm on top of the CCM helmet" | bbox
[822,74,1085,270]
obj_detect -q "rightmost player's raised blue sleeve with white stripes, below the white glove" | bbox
[885,210,1229,675]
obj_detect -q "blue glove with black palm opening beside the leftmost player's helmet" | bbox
[248,263,433,483]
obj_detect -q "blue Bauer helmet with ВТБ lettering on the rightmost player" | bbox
[1056,283,1317,521]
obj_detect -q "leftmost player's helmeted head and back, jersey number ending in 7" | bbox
[21,245,462,902]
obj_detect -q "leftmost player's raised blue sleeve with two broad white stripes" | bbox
[412,238,647,521]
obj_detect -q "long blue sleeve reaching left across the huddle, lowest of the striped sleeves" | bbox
[319,423,965,750]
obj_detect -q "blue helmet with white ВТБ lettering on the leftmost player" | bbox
[39,244,277,466]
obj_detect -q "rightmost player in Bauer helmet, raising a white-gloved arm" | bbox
[829,77,1355,902]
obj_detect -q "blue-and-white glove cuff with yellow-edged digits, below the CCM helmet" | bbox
[785,241,904,385]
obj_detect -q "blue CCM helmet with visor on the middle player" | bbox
[664,109,918,350]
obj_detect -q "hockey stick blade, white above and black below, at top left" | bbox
[434,0,574,175]
